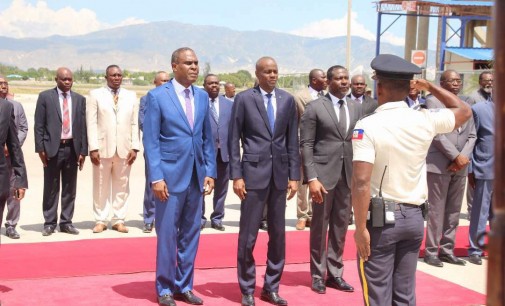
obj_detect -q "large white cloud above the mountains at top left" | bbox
[0,0,145,38]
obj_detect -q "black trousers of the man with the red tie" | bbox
[42,142,78,226]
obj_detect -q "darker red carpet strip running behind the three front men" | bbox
[0,226,474,280]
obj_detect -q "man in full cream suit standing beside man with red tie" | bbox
[86,65,140,233]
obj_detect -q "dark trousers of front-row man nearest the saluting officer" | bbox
[310,176,351,279]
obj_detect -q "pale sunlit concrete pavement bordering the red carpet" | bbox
[1,95,487,302]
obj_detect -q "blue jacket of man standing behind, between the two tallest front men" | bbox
[209,96,233,163]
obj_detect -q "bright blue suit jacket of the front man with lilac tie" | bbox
[143,82,217,193]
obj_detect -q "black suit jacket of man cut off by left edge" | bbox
[0,99,28,194]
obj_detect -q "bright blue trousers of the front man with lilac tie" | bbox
[155,170,203,296]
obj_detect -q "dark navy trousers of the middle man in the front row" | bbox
[237,182,286,294]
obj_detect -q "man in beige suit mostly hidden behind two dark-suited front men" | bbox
[294,69,327,230]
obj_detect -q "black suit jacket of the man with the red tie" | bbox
[34,87,88,158]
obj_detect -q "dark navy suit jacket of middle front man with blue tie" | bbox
[228,87,300,190]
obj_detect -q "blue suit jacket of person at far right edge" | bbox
[471,101,495,180]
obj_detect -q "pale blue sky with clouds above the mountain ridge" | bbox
[0,0,403,44]
